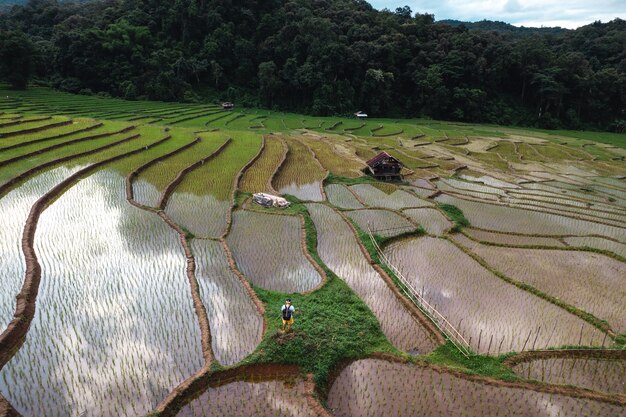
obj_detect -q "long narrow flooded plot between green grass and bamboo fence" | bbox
[307,204,436,353]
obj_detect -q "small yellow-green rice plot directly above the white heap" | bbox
[239,135,286,193]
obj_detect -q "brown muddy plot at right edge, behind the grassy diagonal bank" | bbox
[455,236,626,333]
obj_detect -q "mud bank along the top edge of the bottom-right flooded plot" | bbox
[328,353,626,406]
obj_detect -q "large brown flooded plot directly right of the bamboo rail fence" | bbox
[385,237,604,354]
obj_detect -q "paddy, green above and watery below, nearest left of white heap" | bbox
[165,133,261,237]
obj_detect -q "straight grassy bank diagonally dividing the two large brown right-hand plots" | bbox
[445,237,618,339]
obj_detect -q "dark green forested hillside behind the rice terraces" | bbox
[0,0,626,131]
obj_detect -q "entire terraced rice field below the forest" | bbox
[0,83,626,417]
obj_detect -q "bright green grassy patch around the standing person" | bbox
[238,195,404,389]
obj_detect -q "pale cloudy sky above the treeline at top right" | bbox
[368,0,626,29]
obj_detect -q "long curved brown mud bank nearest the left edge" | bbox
[0,138,169,369]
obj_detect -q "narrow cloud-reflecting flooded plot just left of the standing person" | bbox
[191,239,263,366]
